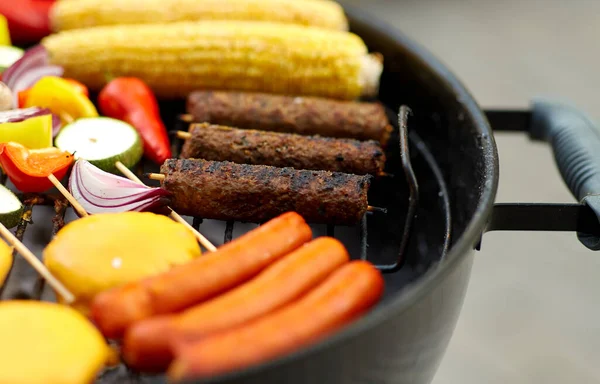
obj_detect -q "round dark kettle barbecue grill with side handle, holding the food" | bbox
[2,3,600,384]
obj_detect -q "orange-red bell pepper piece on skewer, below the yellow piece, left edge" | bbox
[0,142,73,193]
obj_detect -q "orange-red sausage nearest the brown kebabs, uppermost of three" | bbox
[91,212,312,338]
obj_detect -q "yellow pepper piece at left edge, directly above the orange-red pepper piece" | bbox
[0,114,52,149]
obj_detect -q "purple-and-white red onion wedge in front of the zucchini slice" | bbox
[69,159,169,214]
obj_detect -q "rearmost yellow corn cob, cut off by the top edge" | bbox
[50,0,348,31]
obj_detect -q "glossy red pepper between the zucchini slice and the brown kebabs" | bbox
[98,77,171,164]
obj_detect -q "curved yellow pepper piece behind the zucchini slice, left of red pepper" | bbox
[25,76,98,124]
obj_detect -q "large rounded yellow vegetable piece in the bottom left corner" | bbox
[0,300,111,384]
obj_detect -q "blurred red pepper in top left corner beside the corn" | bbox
[0,0,55,45]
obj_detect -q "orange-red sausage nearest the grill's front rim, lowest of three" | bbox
[169,261,384,381]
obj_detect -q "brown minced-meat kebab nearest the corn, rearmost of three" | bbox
[187,91,392,146]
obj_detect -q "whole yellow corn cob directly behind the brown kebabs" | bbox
[42,21,383,99]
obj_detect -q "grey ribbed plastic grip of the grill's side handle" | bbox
[529,100,600,250]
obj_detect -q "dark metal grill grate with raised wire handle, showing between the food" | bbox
[0,106,450,384]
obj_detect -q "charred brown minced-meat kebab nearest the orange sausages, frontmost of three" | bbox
[160,159,371,225]
